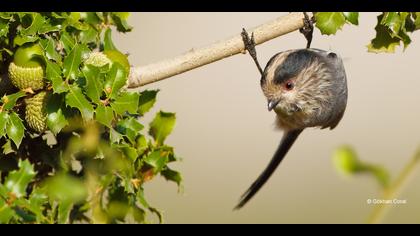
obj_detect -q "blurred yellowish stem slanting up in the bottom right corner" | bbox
[367,148,420,224]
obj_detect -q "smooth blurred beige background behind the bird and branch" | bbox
[114,13,420,223]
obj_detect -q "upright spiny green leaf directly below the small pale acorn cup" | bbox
[82,65,103,104]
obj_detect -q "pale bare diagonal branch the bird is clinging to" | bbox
[128,12,311,88]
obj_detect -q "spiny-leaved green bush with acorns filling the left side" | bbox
[0,12,181,223]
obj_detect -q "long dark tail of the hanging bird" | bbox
[234,129,302,210]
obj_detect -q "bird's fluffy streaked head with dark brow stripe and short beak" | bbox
[260,49,337,116]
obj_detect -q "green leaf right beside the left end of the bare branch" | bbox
[104,63,127,98]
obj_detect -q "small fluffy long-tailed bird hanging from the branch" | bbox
[234,30,348,210]
